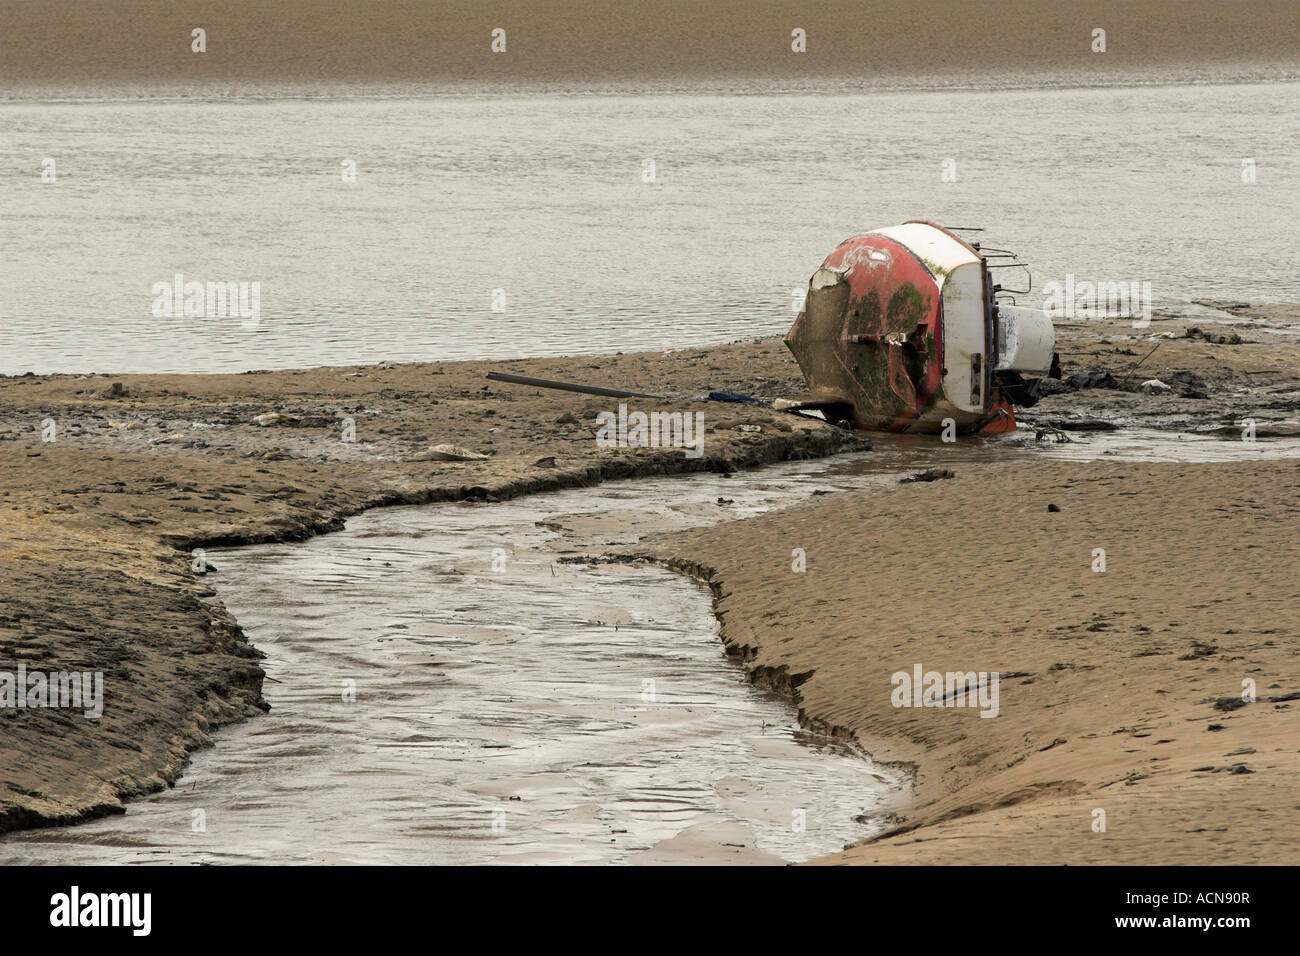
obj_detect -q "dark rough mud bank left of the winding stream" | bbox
[0,343,867,831]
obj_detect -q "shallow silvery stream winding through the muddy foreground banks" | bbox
[0,431,1300,864]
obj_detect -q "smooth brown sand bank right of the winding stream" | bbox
[636,462,1300,865]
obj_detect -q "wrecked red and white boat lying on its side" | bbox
[780,220,1061,433]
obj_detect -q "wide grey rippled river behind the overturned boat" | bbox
[0,83,1300,373]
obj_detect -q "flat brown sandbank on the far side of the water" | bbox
[0,0,1300,92]
